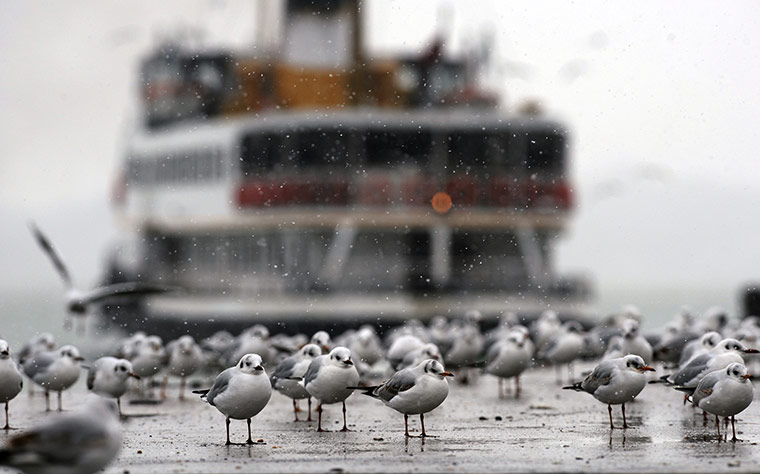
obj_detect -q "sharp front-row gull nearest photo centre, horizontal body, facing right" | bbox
[351,359,454,438]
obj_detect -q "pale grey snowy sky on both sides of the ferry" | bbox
[0,1,760,322]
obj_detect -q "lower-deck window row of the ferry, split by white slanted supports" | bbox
[145,232,527,290]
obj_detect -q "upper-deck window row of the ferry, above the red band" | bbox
[127,130,566,185]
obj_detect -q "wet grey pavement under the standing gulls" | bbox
[0,365,760,473]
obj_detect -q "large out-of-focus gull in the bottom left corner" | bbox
[0,397,122,474]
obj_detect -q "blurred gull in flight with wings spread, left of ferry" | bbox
[29,222,174,329]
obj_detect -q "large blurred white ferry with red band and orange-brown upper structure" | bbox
[102,0,590,336]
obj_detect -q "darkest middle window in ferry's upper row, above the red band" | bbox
[364,130,432,166]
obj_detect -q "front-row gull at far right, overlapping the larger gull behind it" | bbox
[687,362,755,442]
